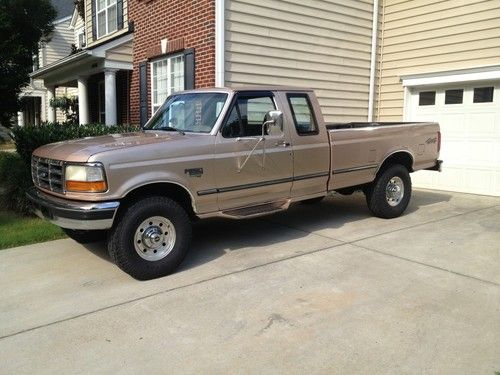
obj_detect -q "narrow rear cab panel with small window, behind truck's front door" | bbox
[282,91,330,198]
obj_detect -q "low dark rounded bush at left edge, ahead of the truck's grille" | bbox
[0,152,33,215]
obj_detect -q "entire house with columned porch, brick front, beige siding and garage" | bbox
[28,0,500,195]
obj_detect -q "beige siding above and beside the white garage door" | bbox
[376,0,500,121]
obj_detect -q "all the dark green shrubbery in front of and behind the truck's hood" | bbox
[0,123,139,215]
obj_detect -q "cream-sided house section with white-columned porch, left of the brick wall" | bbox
[31,0,133,125]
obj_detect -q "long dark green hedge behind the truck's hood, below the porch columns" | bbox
[12,123,139,165]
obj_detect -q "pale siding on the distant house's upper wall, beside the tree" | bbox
[40,19,73,67]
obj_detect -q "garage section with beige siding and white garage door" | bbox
[375,0,500,196]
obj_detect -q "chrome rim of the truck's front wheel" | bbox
[134,216,176,262]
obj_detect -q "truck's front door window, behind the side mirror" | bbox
[222,94,276,138]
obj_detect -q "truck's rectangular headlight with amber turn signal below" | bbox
[64,164,108,193]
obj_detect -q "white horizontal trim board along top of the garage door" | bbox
[400,66,500,87]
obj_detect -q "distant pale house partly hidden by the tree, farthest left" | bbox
[17,0,74,125]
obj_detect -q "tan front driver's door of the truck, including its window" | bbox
[214,91,293,210]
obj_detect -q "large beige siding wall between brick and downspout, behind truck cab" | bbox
[225,0,373,121]
